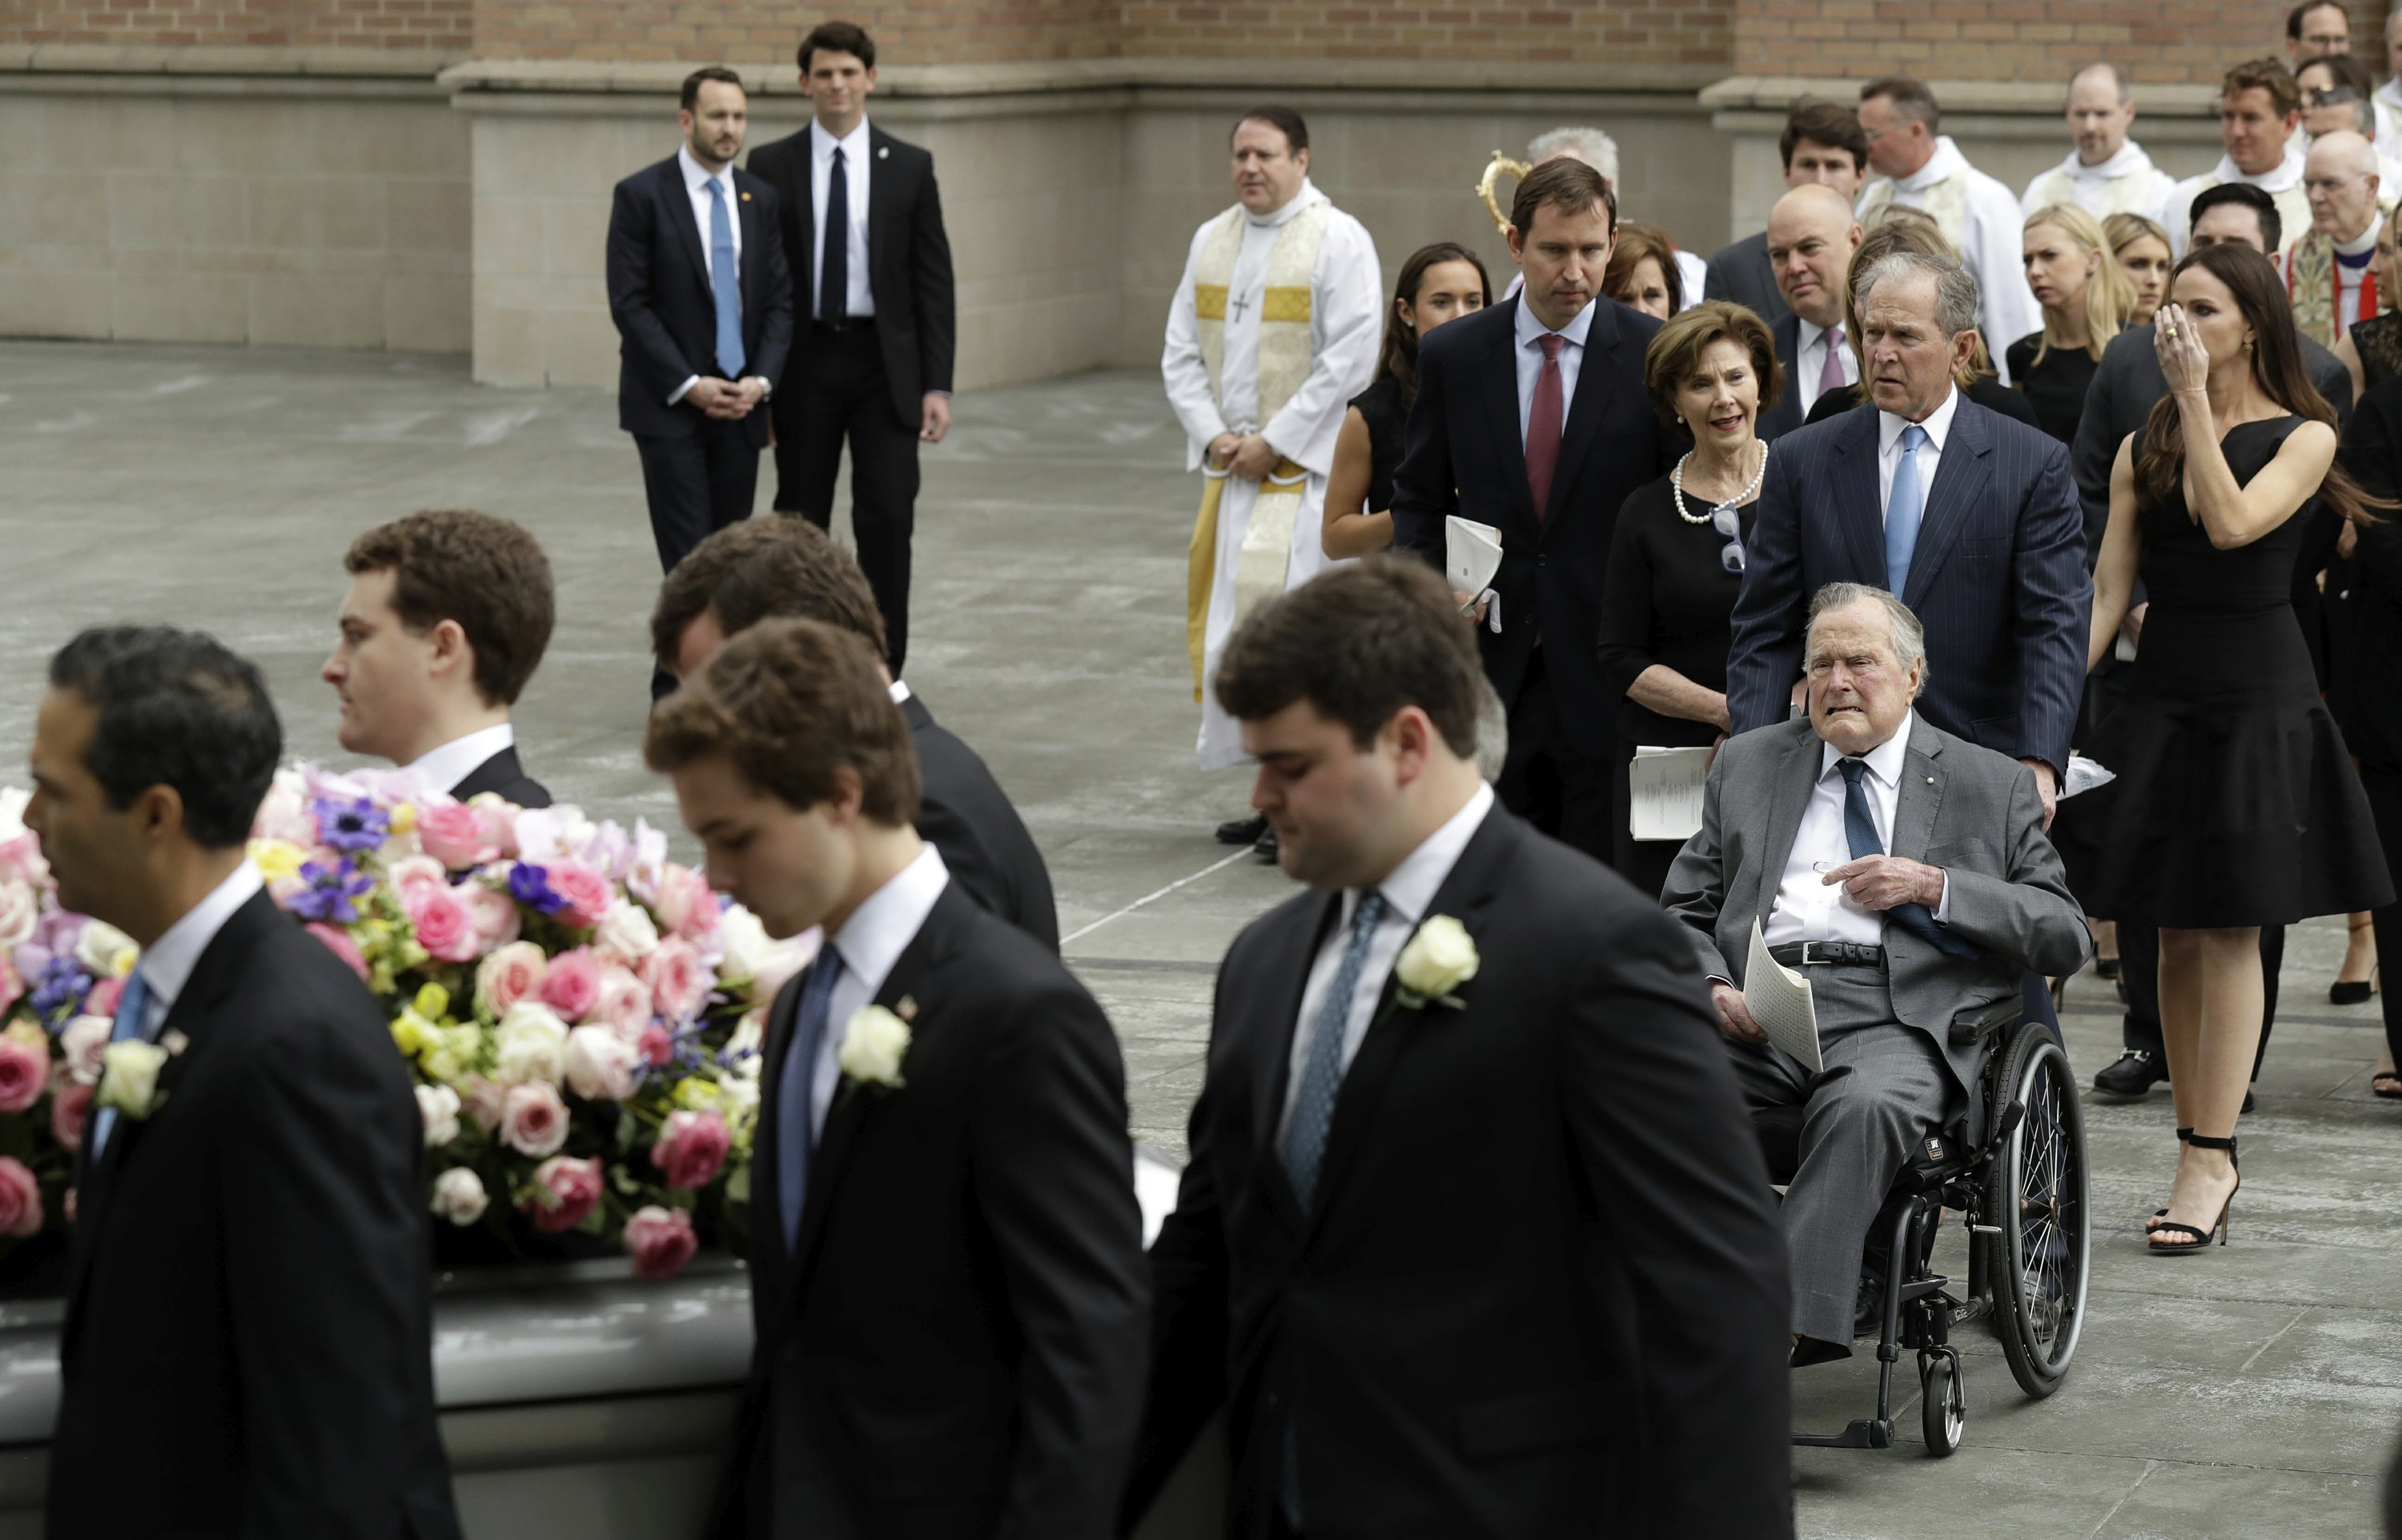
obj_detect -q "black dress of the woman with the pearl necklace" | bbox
[1600,475,1758,896]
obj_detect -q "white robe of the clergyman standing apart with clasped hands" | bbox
[1160,180,1384,768]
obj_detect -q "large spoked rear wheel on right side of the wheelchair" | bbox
[1984,1026,2092,1401]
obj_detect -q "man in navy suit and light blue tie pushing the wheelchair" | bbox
[1727,252,2092,824]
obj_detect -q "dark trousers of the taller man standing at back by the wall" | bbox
[776,322,920,677]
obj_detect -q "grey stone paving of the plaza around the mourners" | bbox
[0,343,2402,1540]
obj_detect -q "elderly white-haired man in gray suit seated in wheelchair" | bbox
[1662,584,2092,1365]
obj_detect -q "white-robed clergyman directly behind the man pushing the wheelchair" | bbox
[1859,74,2044,384]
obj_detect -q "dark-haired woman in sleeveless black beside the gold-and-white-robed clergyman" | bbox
[1319,240,1492,559]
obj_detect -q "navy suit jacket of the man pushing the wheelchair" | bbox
[1727,399,2092,772]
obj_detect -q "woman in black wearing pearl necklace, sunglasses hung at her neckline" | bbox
[1600,300,1785,896]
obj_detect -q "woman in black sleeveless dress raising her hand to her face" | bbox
[2056,243,2395,1254]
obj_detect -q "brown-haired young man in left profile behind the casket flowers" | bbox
[317,509,555,808]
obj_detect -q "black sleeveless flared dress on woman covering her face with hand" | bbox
[2054,415,2395,930]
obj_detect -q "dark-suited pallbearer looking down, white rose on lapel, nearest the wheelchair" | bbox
[1129,555,1792,1540]
